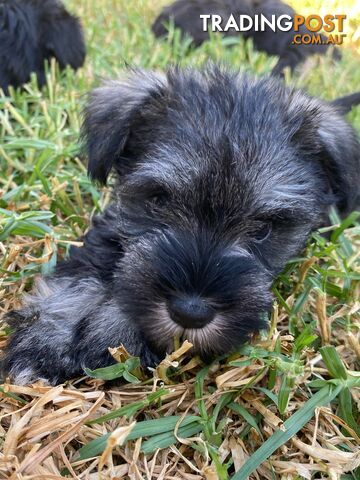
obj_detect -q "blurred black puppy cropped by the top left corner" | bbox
[0,0,85,92]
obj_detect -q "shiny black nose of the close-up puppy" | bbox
[168,297,215,328]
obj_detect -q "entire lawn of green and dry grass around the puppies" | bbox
[0,0,360,480]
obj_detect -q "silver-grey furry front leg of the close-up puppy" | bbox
[2,277,155,384]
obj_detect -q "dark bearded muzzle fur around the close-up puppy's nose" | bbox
[115,231,272,360]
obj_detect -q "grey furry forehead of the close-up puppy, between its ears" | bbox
[130,71,320,203]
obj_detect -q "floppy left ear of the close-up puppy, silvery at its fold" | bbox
[82,71,166,184]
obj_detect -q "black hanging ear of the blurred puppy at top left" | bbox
[41,5,86,70]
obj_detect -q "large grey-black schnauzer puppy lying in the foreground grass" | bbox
[3,66,360,384]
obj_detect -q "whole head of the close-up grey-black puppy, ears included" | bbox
[84,68,359,357]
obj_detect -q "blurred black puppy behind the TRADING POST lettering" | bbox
[152,0,341,75]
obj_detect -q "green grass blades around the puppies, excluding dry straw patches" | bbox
[0,0,360,479]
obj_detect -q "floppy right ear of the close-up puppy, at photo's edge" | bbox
[293,99,360,214]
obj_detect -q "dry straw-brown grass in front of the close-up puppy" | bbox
[0,249,360,480]
